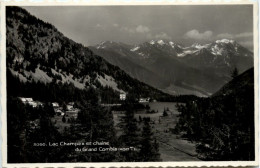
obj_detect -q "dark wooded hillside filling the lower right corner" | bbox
[175,68,255,161]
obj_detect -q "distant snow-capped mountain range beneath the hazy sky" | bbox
[90,39,253,96]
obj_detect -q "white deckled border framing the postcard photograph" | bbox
[0,0,259,168]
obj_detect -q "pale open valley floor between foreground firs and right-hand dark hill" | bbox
[113,102,199,161]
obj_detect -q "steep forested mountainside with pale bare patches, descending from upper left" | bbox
[6,7,171,98]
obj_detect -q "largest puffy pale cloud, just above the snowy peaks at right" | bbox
[184,29,213,40]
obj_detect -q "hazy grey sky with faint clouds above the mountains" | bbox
[24,5,253,49]
